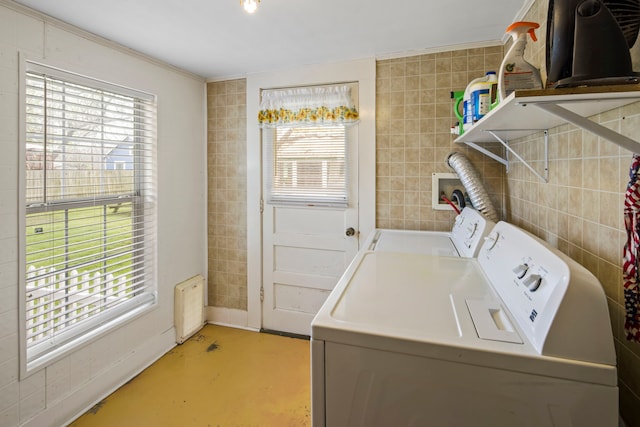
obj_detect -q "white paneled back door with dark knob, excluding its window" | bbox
[261,126,359,335]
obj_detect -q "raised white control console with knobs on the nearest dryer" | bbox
[478,222,615,363]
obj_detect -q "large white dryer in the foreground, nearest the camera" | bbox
[311,222,618,427]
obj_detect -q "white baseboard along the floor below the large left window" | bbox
[22,328,176,427]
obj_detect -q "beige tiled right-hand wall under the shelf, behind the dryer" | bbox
[506,0,640,427]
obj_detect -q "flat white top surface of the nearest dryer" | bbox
[330,252,496,342]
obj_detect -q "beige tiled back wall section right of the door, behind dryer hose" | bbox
[376,46,504,231]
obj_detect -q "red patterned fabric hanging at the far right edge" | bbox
[622,154,640,342]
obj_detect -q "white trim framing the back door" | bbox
[245,58,376,329]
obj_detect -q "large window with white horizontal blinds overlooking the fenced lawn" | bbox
[21,62,156,371]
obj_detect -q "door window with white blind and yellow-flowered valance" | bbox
[258,83,359,207]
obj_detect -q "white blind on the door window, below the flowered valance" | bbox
[263,125,348,207]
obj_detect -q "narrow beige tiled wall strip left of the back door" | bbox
[207,79,247,310]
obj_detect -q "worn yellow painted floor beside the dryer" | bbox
[71,325,311,427]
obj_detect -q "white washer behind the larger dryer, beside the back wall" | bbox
[370,208,495,257]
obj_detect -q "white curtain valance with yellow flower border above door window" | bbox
[258,84,358,128]
